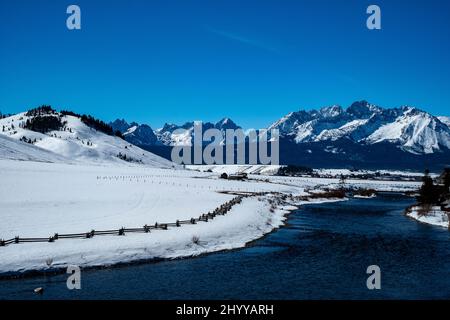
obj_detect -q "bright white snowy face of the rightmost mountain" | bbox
[367,108,450,154]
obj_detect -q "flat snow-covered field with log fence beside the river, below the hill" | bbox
[0,160,418,274]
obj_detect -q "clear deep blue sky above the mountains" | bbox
[0,0,450,128]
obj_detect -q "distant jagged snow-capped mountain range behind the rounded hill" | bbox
[111,101,450,154]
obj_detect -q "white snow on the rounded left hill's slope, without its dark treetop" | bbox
[0,113,174,168]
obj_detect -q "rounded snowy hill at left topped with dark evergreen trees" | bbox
[0,112,173,168]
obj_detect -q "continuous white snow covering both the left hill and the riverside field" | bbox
[0,113,419,274]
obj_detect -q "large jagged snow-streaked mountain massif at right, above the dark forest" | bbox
[269,101,450,154]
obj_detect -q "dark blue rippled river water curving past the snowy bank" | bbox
[0,194,450,299]
